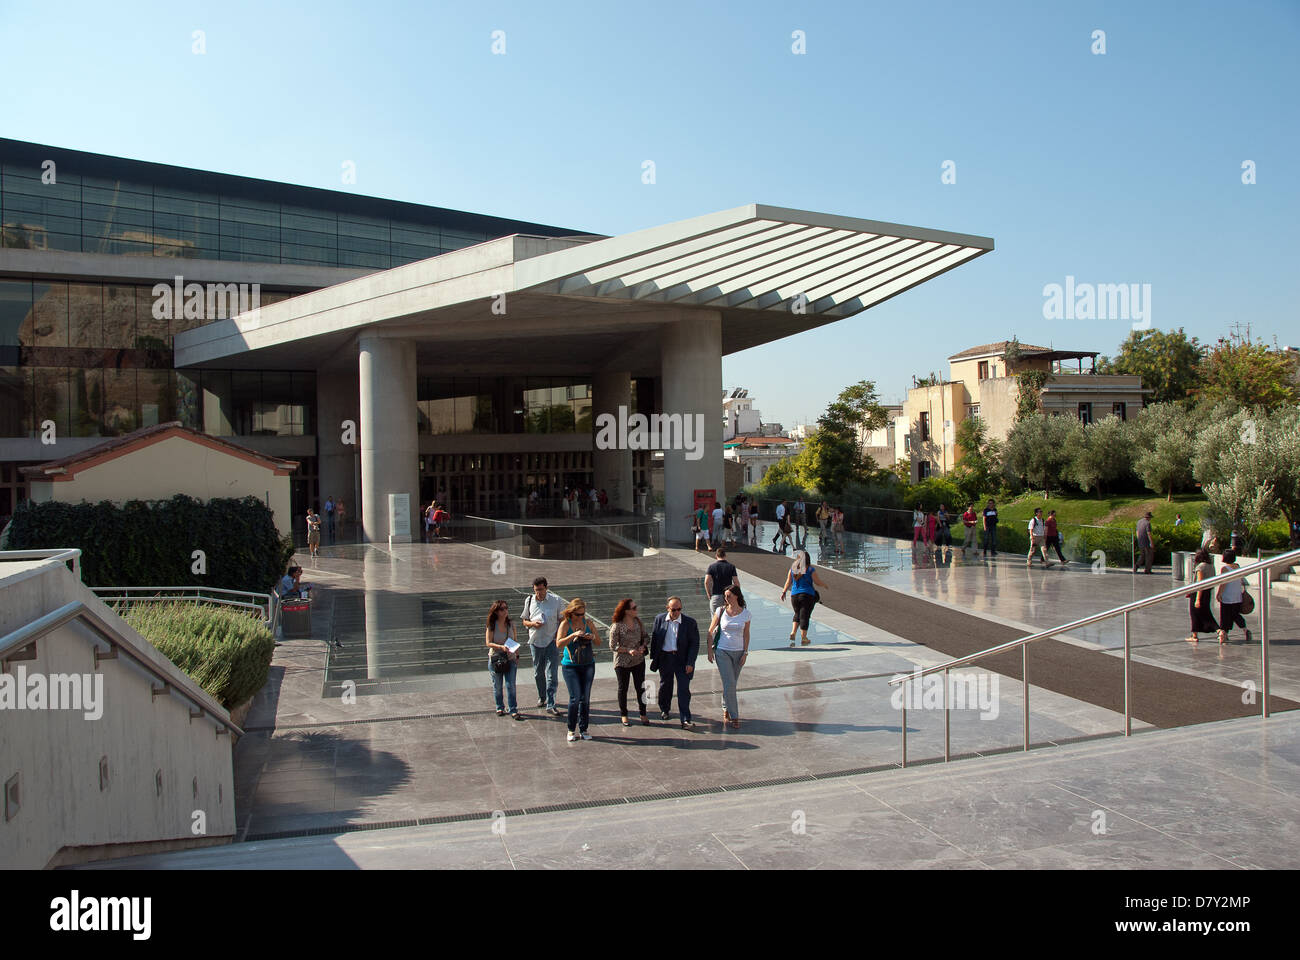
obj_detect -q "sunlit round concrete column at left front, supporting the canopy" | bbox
[358,334,420,542]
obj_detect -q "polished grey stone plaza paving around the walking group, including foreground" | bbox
[83,520,1300,866]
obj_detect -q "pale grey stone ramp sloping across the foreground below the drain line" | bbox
[73,713,1300,870]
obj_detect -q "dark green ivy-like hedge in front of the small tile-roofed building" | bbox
[4,496,294,593]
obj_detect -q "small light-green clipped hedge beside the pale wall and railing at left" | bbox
[124,602,276,710]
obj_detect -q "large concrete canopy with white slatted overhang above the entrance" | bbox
[176,204,993,372]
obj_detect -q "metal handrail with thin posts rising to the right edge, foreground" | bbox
[889,550,1300,766]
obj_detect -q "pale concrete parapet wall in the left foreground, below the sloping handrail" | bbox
[0,563,235,869]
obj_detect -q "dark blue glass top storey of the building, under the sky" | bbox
[0,139,573,269]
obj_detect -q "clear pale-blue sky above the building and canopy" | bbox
[0,0,1300,425]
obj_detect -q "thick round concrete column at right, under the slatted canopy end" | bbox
[660,310,724,542]
